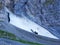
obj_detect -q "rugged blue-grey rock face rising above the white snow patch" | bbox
[6,0,60,38]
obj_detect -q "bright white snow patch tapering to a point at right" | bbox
[6,8,58,39]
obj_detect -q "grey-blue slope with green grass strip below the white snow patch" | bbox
[0,23,60,45]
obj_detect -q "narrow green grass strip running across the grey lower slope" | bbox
[0,30,42,45]
